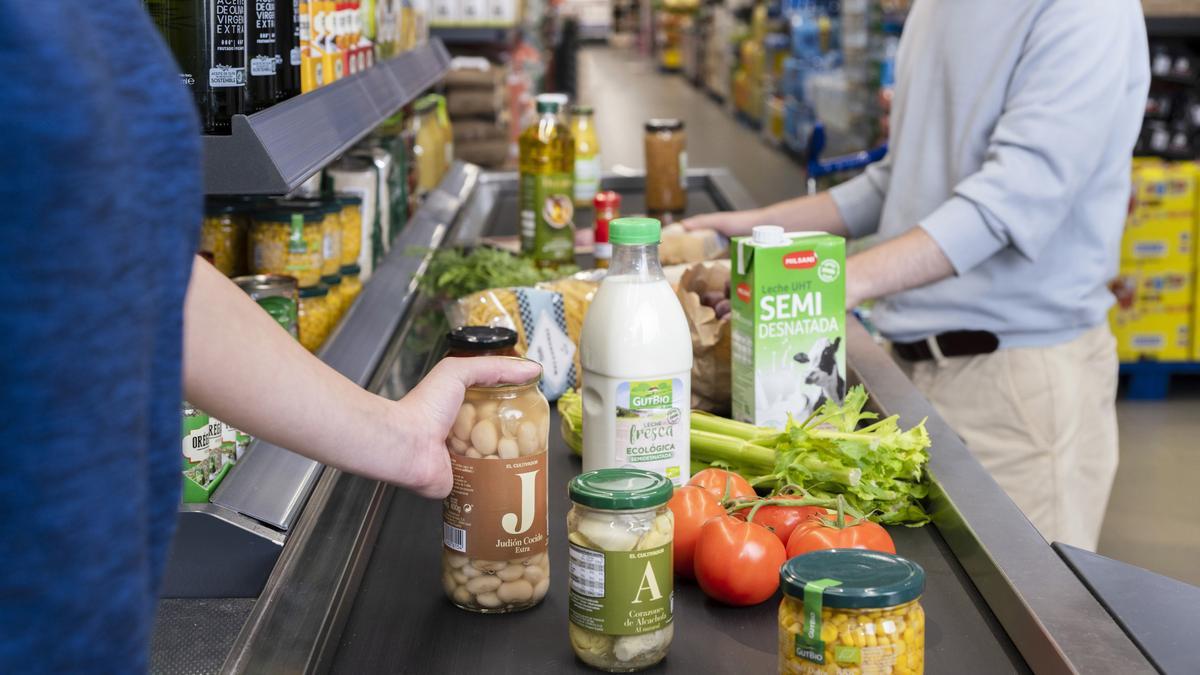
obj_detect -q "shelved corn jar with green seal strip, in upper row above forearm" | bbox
[250,205,324,287]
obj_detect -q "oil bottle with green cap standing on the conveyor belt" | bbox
[520,100,575,267]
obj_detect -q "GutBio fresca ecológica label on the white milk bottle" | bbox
[616,377,691,483]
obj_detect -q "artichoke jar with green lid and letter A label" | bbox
[566,468,674,673]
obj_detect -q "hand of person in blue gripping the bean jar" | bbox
[391,357,541,500]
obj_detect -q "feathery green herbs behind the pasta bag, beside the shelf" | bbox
[414,246,578,300]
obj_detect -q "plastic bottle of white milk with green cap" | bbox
[580,217,691,485]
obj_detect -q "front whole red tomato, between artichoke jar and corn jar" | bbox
[695,515,787,605]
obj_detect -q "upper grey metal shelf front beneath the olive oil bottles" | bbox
[204,40,450,195]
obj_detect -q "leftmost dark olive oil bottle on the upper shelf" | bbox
[146,0,246,133]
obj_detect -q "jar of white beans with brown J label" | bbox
[442,357,550,614]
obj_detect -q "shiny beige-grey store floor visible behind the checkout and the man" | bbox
[578,47,1200,585]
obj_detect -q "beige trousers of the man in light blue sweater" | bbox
[896,324,1117,550]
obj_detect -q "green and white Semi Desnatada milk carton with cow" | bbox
[730,226,846,429]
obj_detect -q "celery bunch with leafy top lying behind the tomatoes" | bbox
[558,387,930,526]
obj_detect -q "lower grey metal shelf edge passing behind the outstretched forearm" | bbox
[162,163,480,598]
